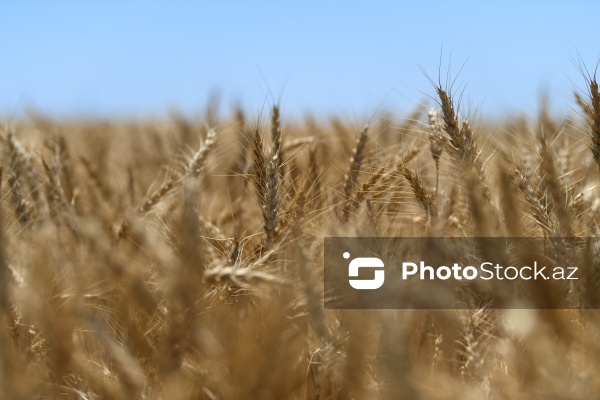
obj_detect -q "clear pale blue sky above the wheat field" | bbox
[0,0,600,117]
